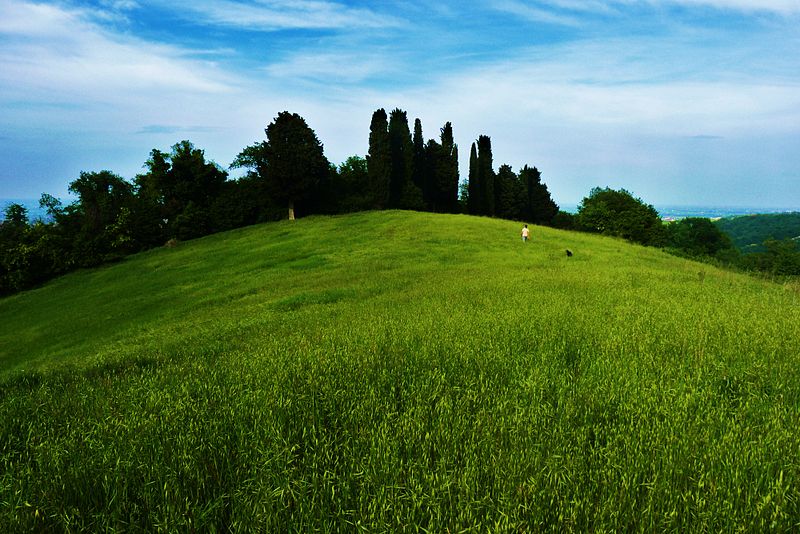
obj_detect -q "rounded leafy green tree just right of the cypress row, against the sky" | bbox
[576,187,665,246]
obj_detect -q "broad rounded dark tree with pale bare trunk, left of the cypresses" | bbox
[263,111,330,220]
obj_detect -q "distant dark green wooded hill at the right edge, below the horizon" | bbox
[714,212,800,252]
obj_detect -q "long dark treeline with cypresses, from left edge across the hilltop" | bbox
[0,109,559,295]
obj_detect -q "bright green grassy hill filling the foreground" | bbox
[0,212,800,532]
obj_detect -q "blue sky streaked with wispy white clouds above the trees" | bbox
[0,0,800,209]
